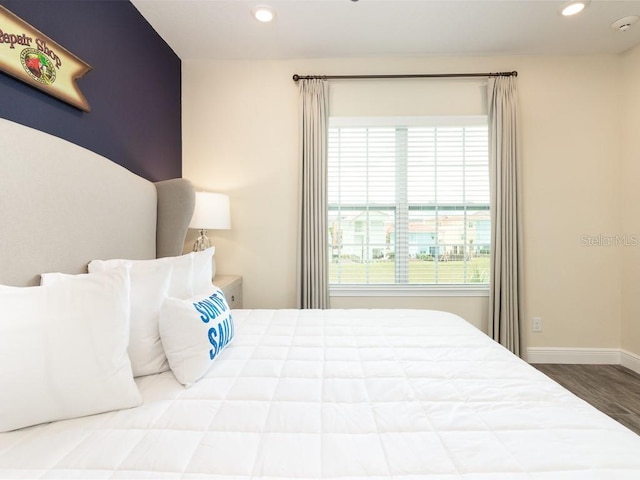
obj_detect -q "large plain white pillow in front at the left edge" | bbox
[0,268,142,432]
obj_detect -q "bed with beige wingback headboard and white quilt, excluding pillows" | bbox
[0,119,640,480]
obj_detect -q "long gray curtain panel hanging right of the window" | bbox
[487,76,522,355]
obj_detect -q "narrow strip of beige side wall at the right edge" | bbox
[620,47,640,355]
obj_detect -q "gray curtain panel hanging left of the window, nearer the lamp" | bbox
[296,79,329,308]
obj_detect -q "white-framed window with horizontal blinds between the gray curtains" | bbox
[328,117,491,285]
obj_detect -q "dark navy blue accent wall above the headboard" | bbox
[0,0,182,181]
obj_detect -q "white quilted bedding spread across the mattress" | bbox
[0,310,640,480]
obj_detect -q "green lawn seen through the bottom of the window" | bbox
[329,257,489,284]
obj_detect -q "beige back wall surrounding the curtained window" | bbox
[183,55,640,348]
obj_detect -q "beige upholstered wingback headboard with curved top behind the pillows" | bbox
[0,119,195,286]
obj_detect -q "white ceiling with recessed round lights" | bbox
[132,0,640,60]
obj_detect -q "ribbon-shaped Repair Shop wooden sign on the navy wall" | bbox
[0,5,91,112]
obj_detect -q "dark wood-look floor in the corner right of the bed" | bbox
[533,364,640,435]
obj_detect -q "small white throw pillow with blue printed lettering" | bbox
[160,287,235,385]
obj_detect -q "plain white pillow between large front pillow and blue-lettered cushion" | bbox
[87,259,173,377]
